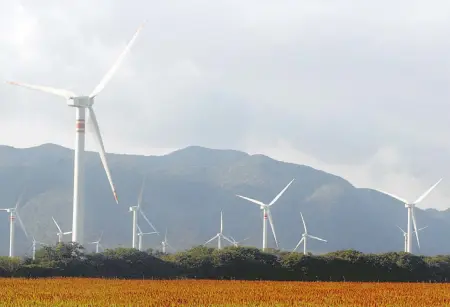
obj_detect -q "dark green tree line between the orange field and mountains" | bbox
[0,243,450,282]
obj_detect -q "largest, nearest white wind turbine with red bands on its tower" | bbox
[8,24,143,245]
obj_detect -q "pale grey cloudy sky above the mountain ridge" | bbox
[0,0,450,209]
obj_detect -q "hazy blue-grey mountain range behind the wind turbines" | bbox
[0,144,450,255]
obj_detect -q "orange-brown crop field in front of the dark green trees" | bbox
[0,278,450,307]
